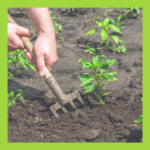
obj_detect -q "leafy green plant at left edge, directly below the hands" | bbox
[8,49,36,74]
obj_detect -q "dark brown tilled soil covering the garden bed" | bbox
[8,8,143,143]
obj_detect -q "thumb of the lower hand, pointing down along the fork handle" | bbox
[36,56,45,77]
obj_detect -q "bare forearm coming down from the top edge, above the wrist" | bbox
[25,8,55,36]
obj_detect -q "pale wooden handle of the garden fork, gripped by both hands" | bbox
[8,14,52,78]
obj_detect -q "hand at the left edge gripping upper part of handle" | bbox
[8,23,33,51]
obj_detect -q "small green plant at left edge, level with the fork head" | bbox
[7,89,28,107]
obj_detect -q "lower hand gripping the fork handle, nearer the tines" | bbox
[24,34,58,77]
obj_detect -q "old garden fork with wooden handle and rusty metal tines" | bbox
[8,14,85,118]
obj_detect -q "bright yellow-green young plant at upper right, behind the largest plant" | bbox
[86,18,121,46]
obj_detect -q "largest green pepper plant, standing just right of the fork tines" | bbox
[78,55,117,104]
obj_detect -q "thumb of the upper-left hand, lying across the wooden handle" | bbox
[16,26,33,37]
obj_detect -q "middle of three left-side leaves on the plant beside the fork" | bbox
[79,74,95,86]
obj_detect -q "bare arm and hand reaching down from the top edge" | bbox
[25,8,58,76]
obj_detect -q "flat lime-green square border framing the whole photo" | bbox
[0,0,146,150]
